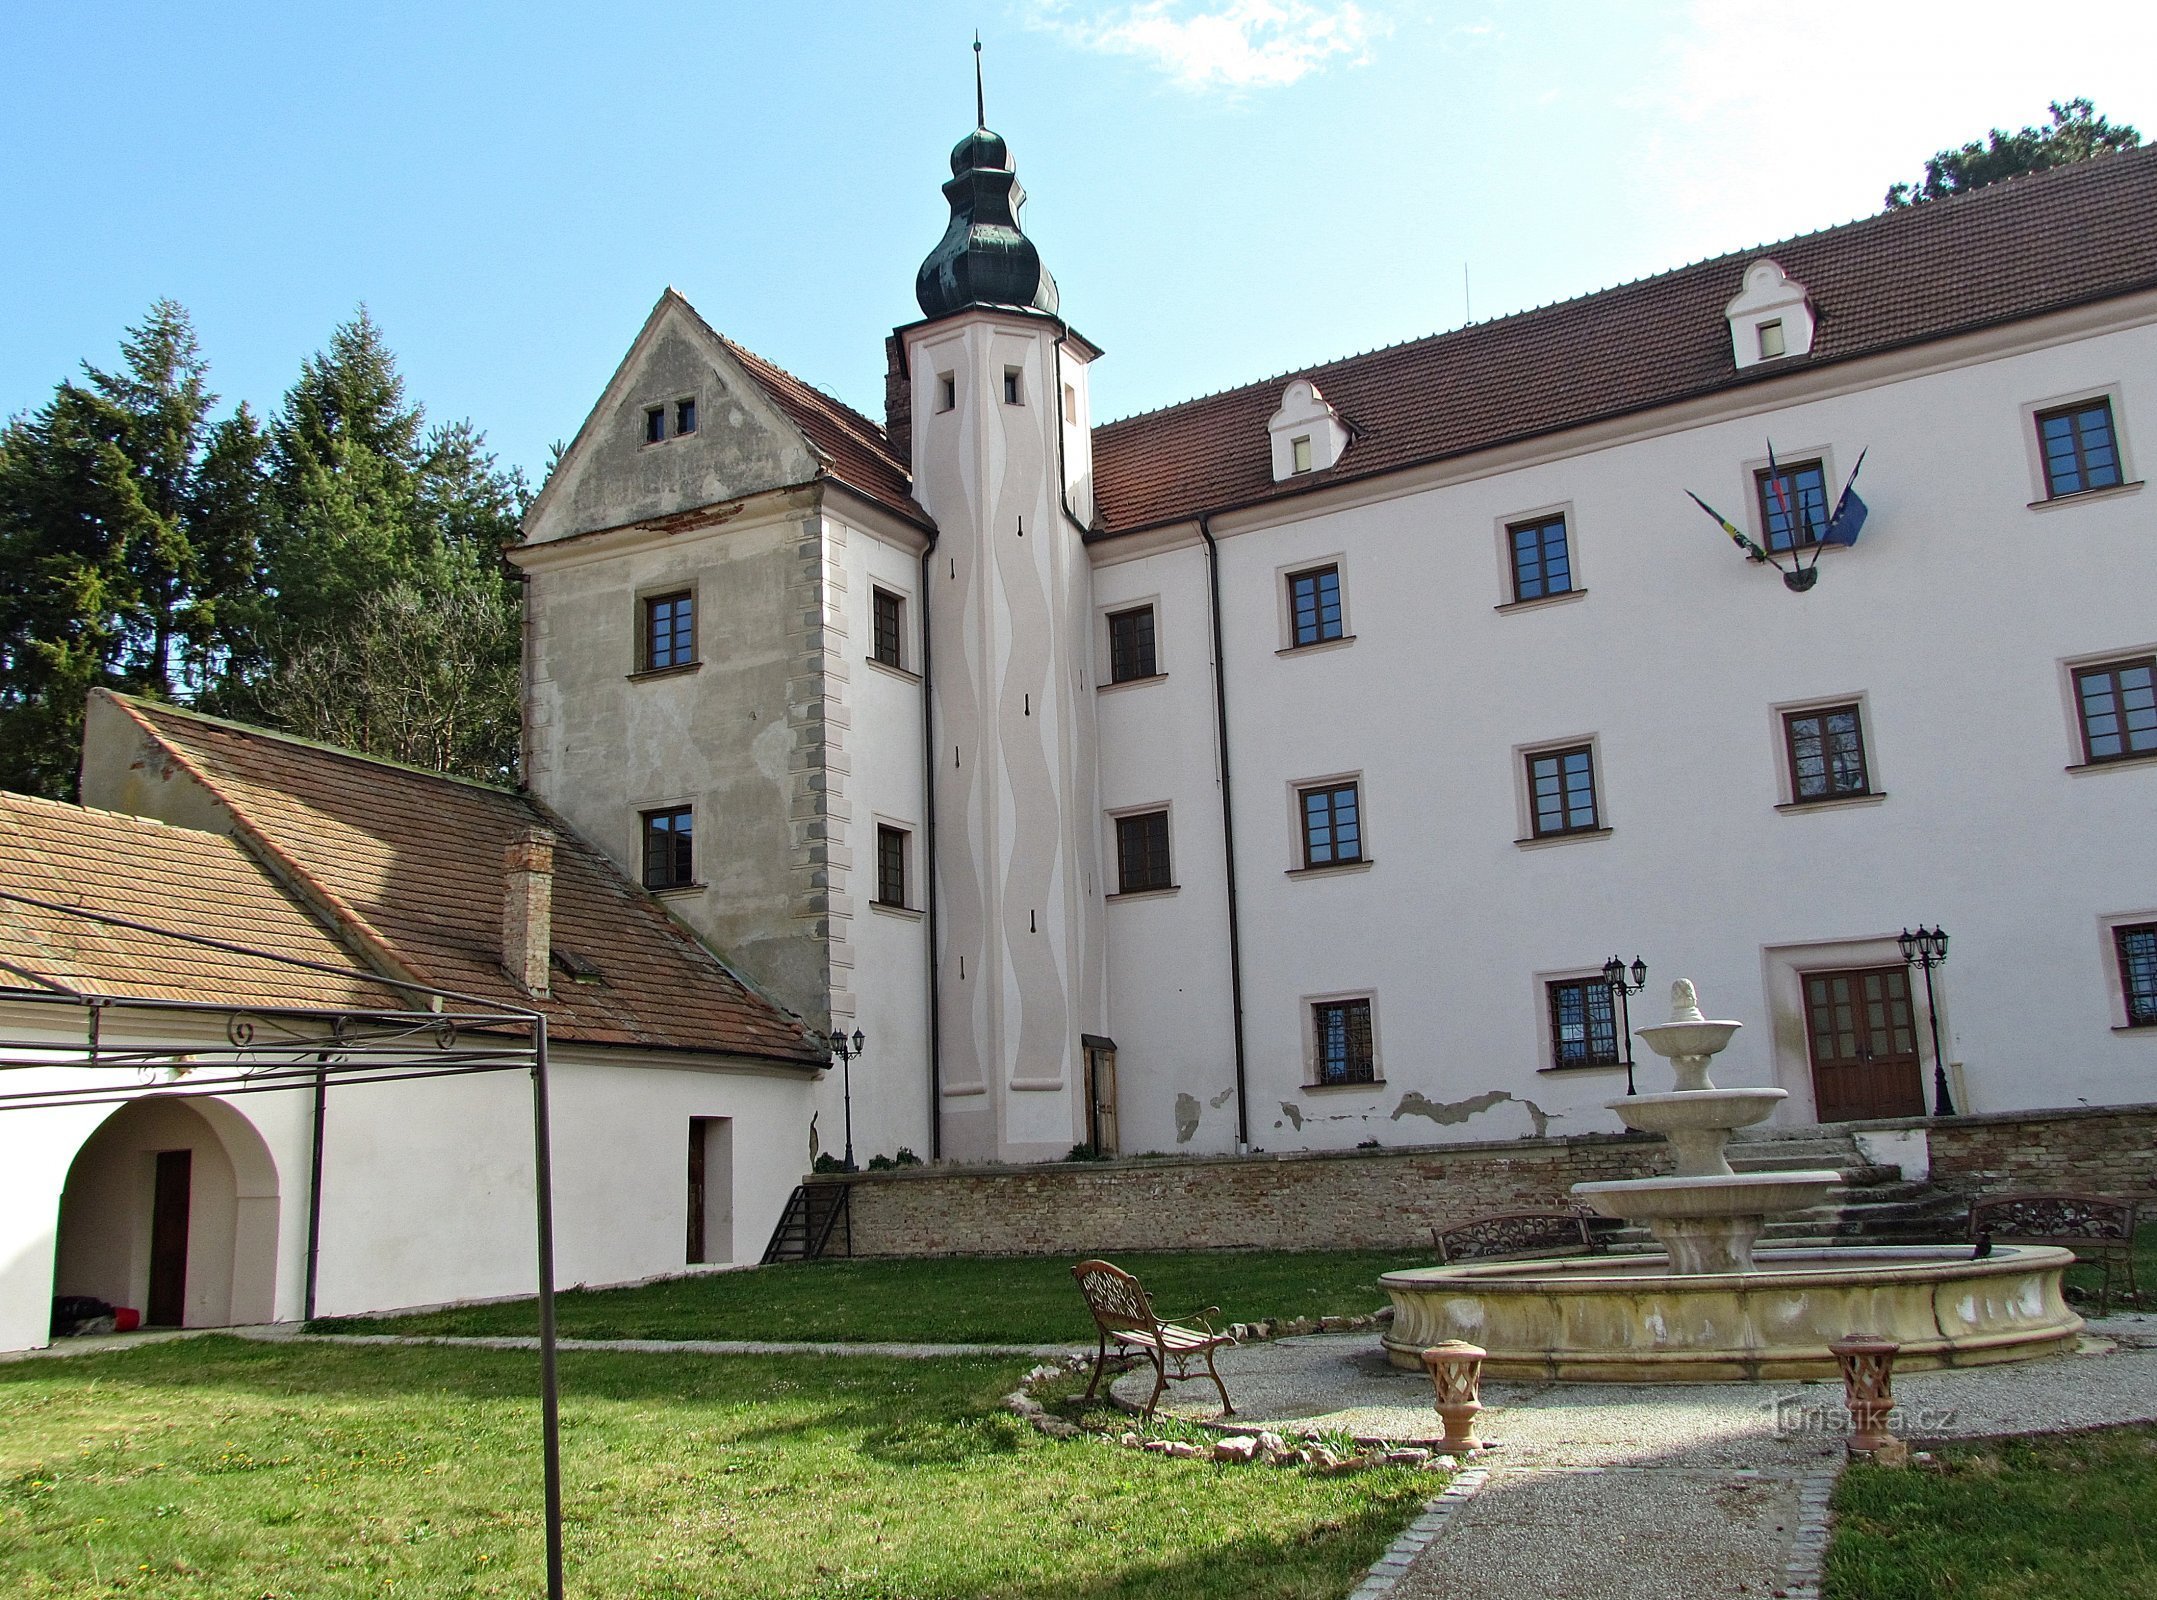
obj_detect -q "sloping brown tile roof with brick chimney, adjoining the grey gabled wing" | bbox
[112,696,826,1067]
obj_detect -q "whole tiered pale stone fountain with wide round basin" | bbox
[1380,979,2082,1382]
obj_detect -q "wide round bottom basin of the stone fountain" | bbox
[1378,1250,2082,1382]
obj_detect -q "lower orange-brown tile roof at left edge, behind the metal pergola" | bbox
[0,794,410,1009]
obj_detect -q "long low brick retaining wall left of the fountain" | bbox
[820,1134,1670,1255]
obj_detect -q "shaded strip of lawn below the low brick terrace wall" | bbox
[315,1251,1428,1343]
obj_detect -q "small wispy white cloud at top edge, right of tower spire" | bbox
[1040,0,1387,91]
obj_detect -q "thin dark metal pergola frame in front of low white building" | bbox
[0,891,563,1600]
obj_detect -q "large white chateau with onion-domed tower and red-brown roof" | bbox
[513,129,2157,1160]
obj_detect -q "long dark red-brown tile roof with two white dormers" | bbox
[1094,147,2157,537]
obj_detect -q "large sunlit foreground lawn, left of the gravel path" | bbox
[0,1339,1434,1600]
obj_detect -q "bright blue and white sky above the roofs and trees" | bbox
[0,0,2157,483]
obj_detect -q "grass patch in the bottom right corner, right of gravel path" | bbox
[1823,1425,2157,1600]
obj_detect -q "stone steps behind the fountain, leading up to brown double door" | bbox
[1609,1128,1967,1251]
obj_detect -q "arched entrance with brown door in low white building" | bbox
[52,1095,278,1328]
